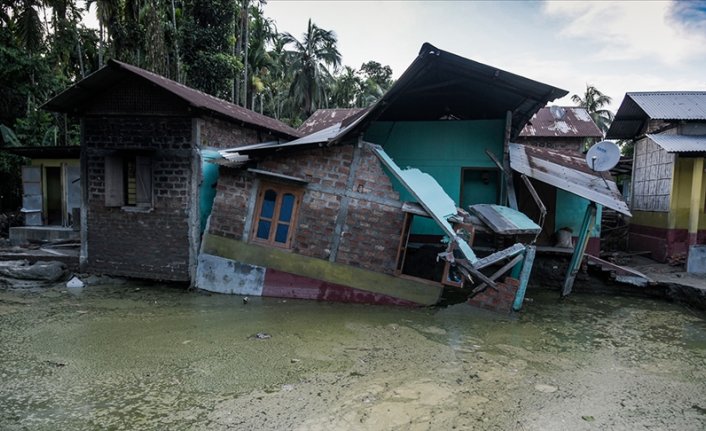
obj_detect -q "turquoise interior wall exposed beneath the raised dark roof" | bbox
[364,120,506,235]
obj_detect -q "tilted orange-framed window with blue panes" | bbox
[252,183,301,248]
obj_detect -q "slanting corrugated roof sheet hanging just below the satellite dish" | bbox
[510,144,632,216]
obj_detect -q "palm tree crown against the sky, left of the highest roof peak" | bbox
[283,19,341,117]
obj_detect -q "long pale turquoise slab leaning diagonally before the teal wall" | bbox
[372,145,478,265]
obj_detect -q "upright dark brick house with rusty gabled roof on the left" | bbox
[44,60,300,282]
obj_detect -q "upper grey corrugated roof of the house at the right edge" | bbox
[606,91,706,139]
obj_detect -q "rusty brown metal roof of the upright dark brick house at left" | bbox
[42,60,302,138]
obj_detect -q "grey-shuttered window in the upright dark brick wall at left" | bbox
[105,155,152,207]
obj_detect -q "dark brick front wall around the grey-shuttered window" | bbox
[83,116,192,281]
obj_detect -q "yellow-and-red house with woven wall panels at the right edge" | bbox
[607,91,706,263]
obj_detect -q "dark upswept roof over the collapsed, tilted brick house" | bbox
[231,43,568,157]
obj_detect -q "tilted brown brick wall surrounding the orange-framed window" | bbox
[209,145,404,274]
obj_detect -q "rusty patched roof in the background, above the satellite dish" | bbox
[520,106,603,138]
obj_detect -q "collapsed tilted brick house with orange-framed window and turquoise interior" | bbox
[196,44,566,305]
